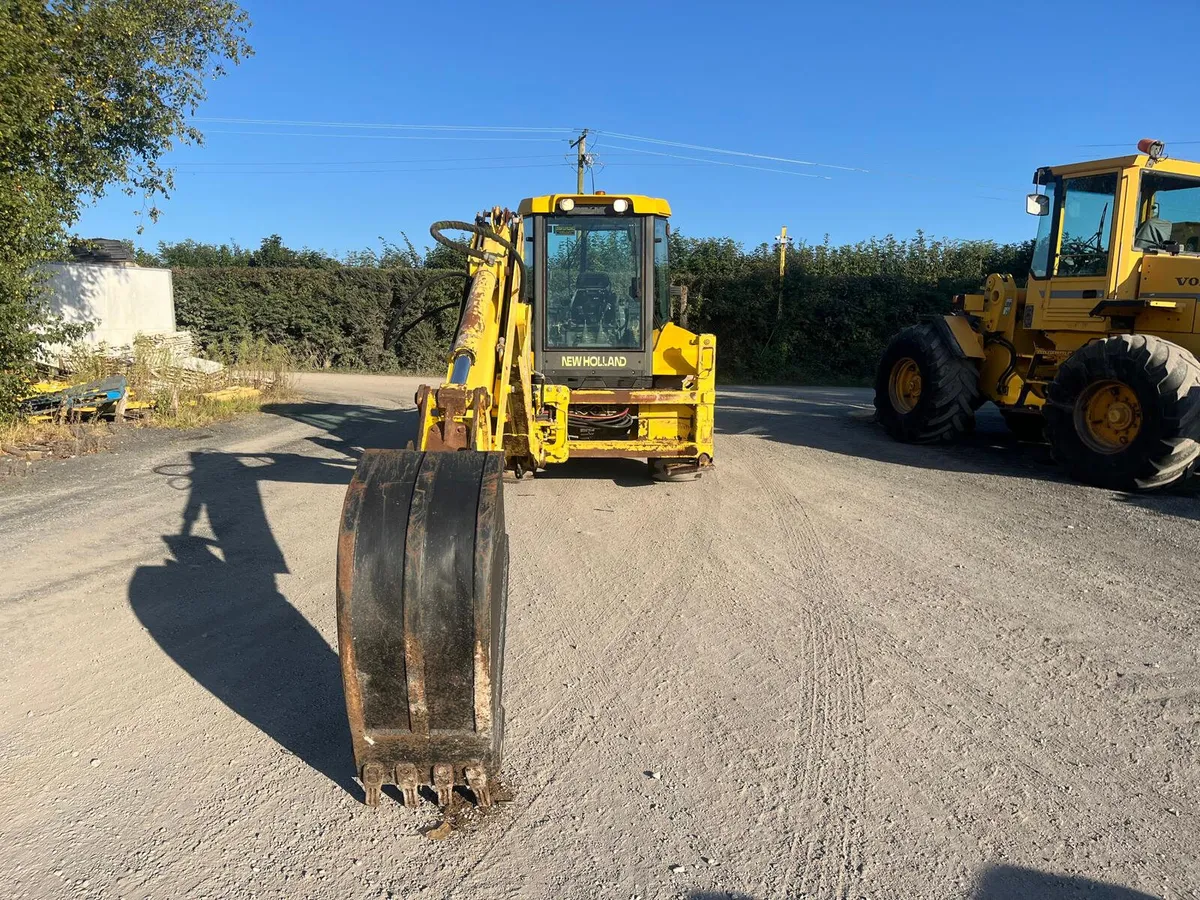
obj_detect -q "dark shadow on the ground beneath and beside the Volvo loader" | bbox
[716,386,1200,518]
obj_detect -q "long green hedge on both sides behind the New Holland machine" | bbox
[173,233,1032,383]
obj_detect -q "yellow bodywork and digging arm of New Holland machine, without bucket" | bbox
[416,194,716,473]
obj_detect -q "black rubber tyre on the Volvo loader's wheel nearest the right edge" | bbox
[1043,335,1200,491]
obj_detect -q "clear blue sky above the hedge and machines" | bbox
[76,0,1200,253]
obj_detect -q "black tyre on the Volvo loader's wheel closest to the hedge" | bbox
[875,323,979,444]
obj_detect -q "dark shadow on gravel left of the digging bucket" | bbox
[128,403,415,794]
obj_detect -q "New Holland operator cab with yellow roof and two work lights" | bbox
[520,193,671,390]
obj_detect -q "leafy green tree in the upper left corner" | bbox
[0,0,251,415]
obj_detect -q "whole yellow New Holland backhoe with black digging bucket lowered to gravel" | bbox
[337,193,716,805]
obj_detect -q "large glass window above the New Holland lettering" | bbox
[545,215,644,350]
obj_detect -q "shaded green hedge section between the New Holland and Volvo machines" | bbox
[672,233,1032,383]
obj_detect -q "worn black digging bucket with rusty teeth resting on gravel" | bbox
[337,450,509,806]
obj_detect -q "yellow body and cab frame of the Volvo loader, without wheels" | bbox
[946,154,1200,408]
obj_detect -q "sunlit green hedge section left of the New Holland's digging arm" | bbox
[172,268,463,371]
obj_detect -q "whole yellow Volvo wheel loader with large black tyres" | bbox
[875,140,1200,490]
